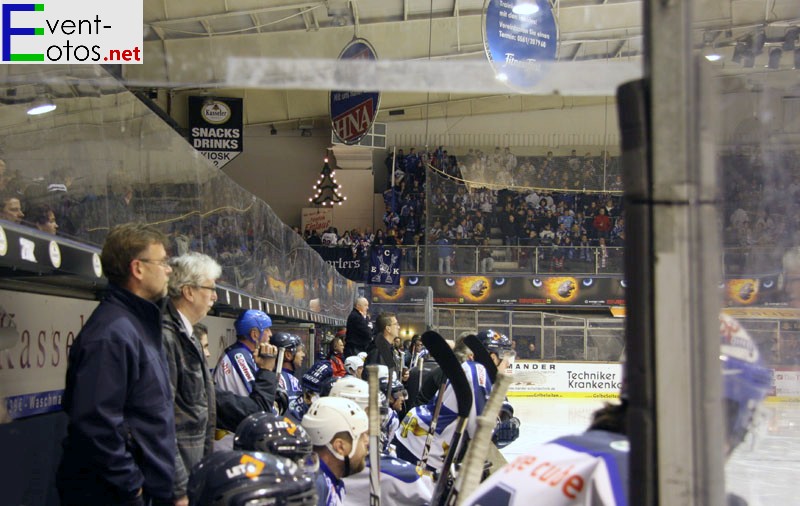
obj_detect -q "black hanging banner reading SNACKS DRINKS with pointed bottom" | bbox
[189,97,244,169]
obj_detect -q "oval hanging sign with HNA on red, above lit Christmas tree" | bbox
[328,39,381,145]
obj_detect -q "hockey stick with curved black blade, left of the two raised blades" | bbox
[422,330,473,505]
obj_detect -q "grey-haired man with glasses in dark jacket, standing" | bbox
[162,253,222,505]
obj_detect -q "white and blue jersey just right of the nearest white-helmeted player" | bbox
[344,455,434,506]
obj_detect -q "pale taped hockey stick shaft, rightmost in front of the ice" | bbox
[445,373,511,506]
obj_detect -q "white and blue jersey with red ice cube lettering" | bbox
[463,430,629,506]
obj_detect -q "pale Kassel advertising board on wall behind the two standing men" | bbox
[0,291,236,419]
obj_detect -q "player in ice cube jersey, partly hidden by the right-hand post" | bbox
[463,314,772,506]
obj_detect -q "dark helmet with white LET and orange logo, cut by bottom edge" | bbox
[189,450,317,506]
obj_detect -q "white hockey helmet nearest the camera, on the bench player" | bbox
[302,397,369,458]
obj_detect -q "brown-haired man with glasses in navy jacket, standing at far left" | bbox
[57,223,177,506]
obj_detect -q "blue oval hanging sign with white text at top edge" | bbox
[483,0,558,89]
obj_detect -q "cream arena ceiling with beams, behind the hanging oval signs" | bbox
[124,0,800,128]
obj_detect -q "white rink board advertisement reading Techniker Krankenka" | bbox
[508,360,622,399]
